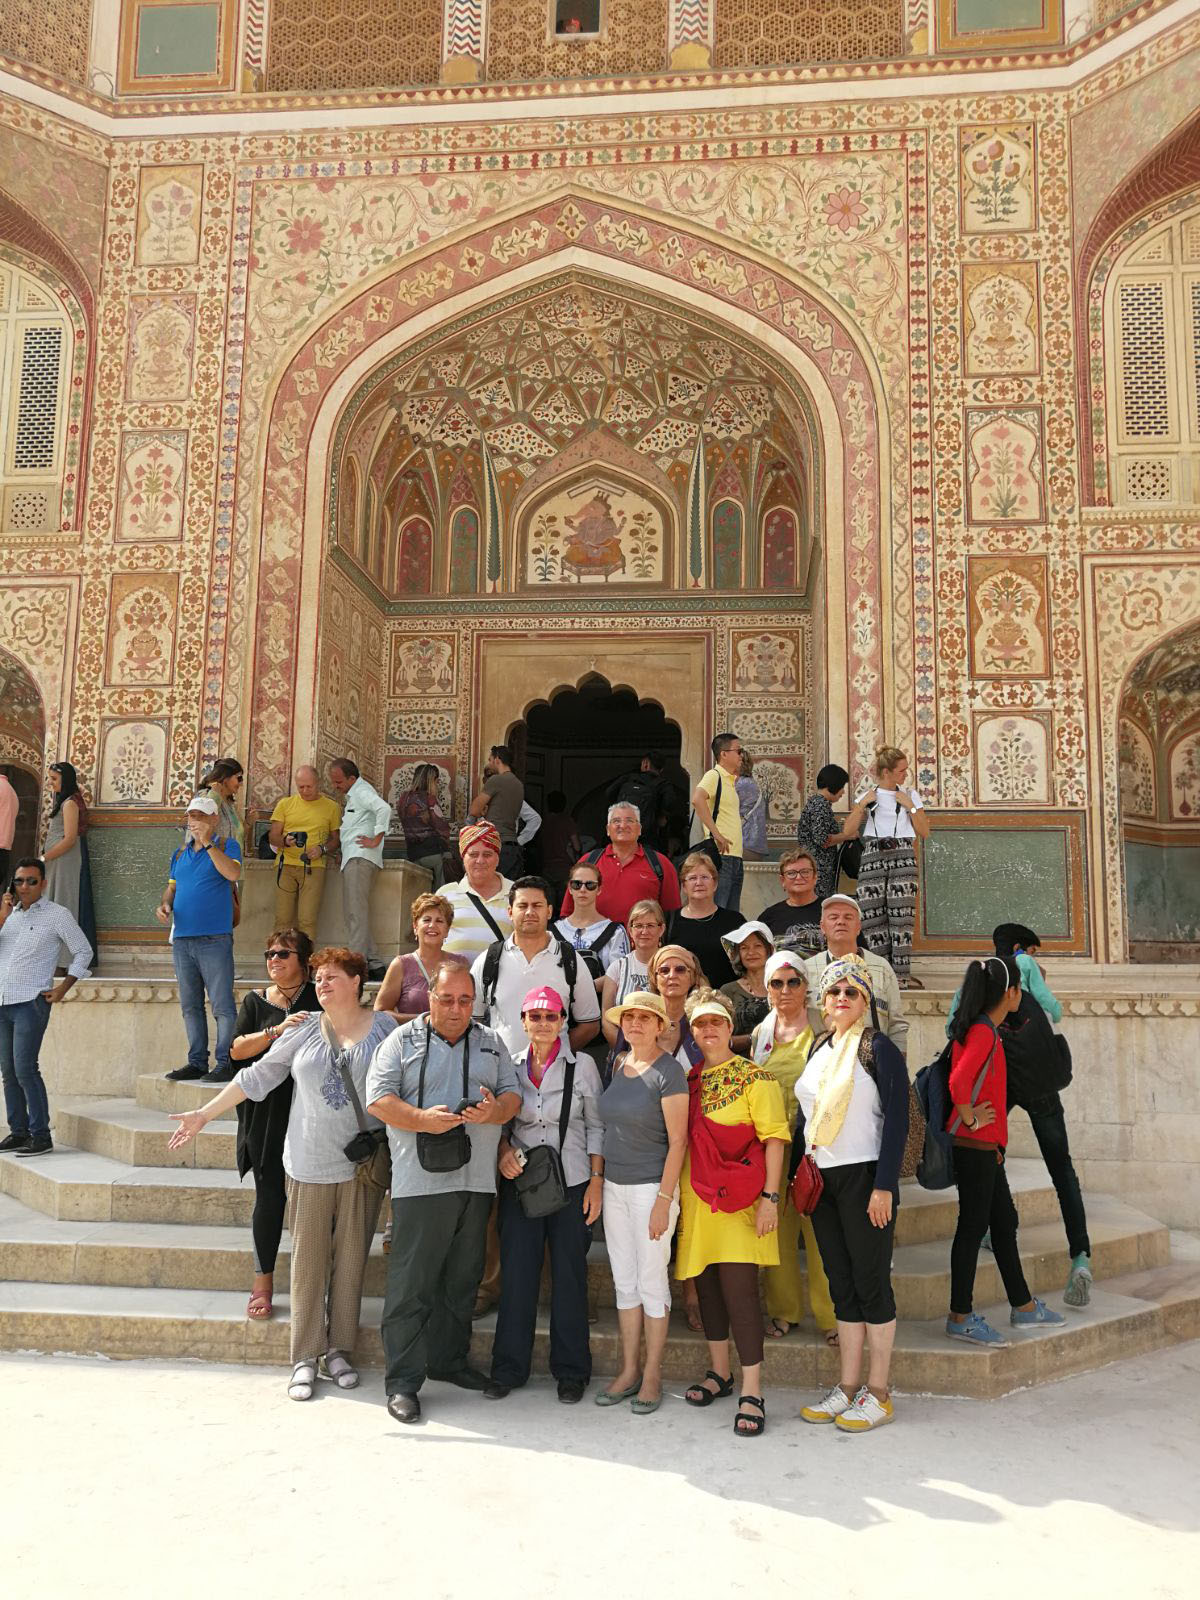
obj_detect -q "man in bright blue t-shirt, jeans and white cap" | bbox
[155,794,242,1083]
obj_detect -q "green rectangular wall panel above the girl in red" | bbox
[922,821,1075,941]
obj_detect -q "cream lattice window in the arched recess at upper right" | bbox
[1104,206,1200,506]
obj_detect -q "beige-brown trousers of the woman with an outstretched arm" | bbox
[288,1178,382,1366]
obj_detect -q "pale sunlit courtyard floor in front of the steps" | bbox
[0,1344,1200,1600]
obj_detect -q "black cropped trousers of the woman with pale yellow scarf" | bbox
[813,1162,896,1323]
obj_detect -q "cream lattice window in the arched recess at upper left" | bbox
[0,261,72,533]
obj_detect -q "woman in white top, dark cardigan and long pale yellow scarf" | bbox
[792,955,909,1434]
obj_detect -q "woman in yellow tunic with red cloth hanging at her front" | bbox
[675,989,792,1438]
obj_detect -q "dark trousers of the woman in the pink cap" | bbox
[491,1178,592,1389]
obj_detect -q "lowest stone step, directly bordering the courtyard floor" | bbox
[0,1259,1200,1395]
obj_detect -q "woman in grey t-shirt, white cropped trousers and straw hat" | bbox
[595,990,688,1416]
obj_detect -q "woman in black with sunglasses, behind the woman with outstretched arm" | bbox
[229,928,320,1322]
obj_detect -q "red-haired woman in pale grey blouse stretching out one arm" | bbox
[170,947,395,1400]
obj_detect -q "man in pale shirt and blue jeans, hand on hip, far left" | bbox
[0,858,91,1155]
